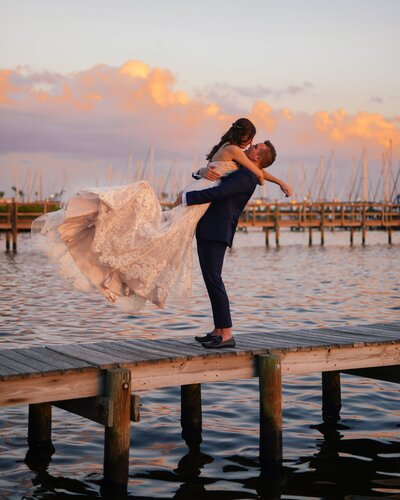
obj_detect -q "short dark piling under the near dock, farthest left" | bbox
[28,403,53,449]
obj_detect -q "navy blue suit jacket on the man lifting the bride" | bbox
[186,167,258,246]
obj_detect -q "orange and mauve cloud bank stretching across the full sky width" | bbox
[0,60,400,169]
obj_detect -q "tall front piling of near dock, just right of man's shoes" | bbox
[258,355,282,464]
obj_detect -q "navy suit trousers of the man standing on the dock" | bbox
[196,234,232,328]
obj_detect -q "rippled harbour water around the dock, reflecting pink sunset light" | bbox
[0,232,400,500]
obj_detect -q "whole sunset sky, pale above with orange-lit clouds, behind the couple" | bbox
[0,0,400,196]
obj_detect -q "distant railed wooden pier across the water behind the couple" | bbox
[0,201,400,252]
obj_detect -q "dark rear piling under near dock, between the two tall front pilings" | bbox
[181,384,202,447]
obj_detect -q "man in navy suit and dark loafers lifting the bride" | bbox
[176,141,284,349]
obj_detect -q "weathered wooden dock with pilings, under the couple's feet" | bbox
[0,321,400,490]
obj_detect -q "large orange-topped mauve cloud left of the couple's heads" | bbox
[0,61,235,157]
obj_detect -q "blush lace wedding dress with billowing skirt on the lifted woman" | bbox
[32,161,238,312]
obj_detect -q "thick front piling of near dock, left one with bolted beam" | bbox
[104,368,131,492]
